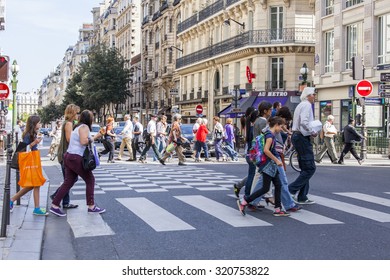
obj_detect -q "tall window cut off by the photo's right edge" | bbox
[378,14,390,64]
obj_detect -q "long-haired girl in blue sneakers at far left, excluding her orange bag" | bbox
[10,115,49,216]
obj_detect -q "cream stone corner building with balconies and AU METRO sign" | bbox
[175,0,315,122]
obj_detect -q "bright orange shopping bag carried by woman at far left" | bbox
[18,151,46,187]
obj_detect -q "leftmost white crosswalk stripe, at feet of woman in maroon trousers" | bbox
[66,200,115,238]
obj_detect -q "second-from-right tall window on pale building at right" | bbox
[345,22,363,69]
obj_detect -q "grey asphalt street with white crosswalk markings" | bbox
[38,138,390,260]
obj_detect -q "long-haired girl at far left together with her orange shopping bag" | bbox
[10,115,48,216]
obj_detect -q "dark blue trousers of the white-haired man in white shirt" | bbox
[288,132,316,201]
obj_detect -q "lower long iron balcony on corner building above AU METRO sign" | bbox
[176,28,315,69]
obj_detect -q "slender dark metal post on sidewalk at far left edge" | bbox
[0,134,13,237]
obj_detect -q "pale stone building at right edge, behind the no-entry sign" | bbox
[314,0,390,153]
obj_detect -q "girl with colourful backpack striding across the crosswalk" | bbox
[237,117,290,217]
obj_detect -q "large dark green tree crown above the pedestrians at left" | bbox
[63,45,130,122]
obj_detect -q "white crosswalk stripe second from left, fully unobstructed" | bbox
[116,197,195,232]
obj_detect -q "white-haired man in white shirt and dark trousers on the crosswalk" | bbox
[288,87,317,204]
